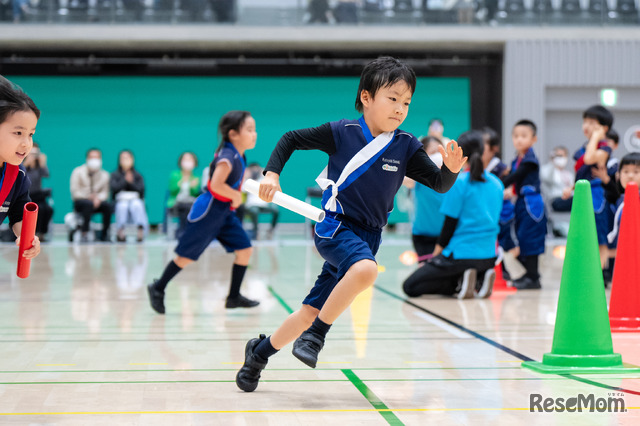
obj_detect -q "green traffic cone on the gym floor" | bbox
[522,180,640,374]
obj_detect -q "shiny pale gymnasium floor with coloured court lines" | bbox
[0,234,640,426]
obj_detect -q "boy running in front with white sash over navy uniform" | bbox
[236,57,466,392]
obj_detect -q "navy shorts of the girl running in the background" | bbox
[175,194,251,260]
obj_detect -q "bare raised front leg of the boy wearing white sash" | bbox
[318,259,378,324]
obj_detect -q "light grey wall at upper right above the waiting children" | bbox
[503,39,640,165]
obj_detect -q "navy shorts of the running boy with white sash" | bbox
[302,215,382,309]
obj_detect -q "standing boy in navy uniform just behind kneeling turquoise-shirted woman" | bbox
[500,120,547,290]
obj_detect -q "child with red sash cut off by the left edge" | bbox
[0,76,40,259]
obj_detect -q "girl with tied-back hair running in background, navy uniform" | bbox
[147,111,259,314]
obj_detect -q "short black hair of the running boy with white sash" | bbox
[356,56,416,112]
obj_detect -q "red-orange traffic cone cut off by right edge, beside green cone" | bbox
[609,182,640,331]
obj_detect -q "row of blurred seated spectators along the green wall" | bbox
[20,143,279,243]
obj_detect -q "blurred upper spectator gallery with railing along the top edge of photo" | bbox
[0,0,640,27]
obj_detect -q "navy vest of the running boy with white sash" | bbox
[322,118,422,228]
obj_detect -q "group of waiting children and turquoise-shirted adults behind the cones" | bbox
[403,105,640,299]
